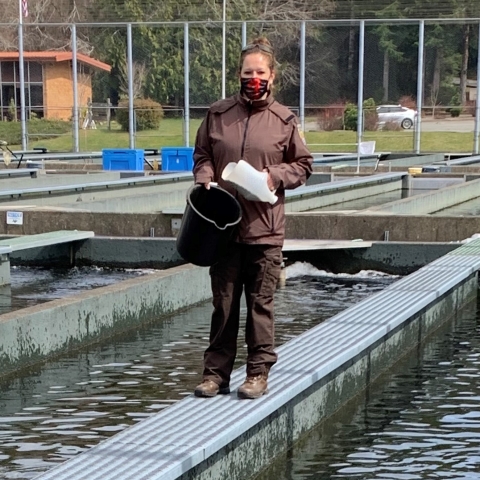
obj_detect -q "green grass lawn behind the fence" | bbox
[0,118,474,152]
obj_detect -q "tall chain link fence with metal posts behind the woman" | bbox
[0,19,479,153]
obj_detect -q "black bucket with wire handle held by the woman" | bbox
[177,185,242,267]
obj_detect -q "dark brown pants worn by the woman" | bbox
[203,243,282,385]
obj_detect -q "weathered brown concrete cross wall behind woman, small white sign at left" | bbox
[0,207,480,242]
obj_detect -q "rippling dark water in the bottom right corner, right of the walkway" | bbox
[255,288,480,480]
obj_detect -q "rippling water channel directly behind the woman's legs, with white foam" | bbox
[0,264,396,479]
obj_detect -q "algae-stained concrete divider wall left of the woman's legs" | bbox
[0,265,211,375]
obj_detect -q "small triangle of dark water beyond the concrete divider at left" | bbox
[0,267,149,315]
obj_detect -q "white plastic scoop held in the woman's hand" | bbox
[222,160,278,205]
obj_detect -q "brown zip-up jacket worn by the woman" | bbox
[193,94,313,245]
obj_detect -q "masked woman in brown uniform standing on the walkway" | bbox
[193,38,312,398]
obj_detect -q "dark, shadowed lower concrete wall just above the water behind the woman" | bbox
[4,237,459,275]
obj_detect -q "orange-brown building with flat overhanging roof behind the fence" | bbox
[0,51,111,120]
